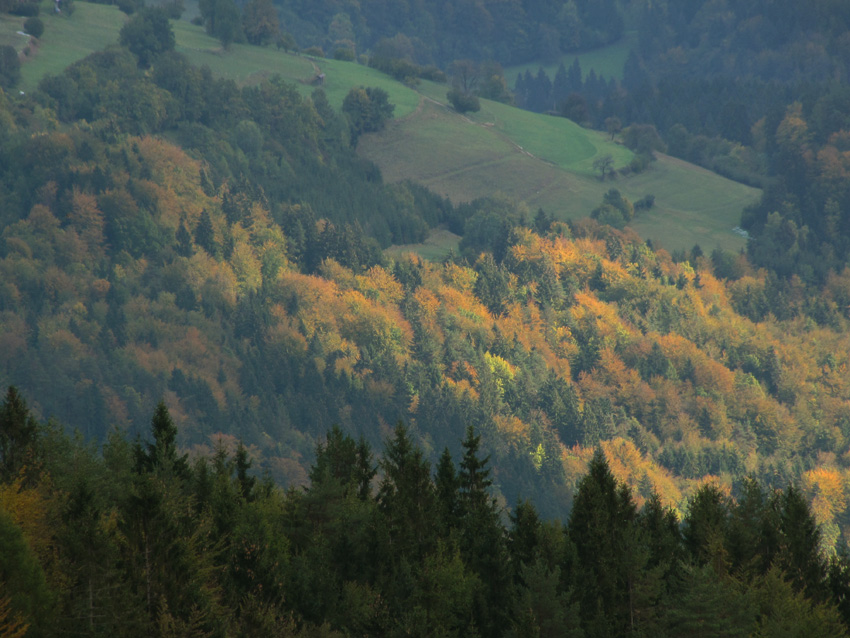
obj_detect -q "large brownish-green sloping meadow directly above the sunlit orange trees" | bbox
[358,100,759,254]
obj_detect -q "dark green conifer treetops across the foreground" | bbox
[0,388,850,638]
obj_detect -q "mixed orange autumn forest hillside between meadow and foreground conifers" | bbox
[0,21,850,540]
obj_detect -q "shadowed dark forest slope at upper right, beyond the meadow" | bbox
[500,0,850,285]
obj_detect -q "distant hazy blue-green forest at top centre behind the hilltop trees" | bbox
[276,0,624,67]
